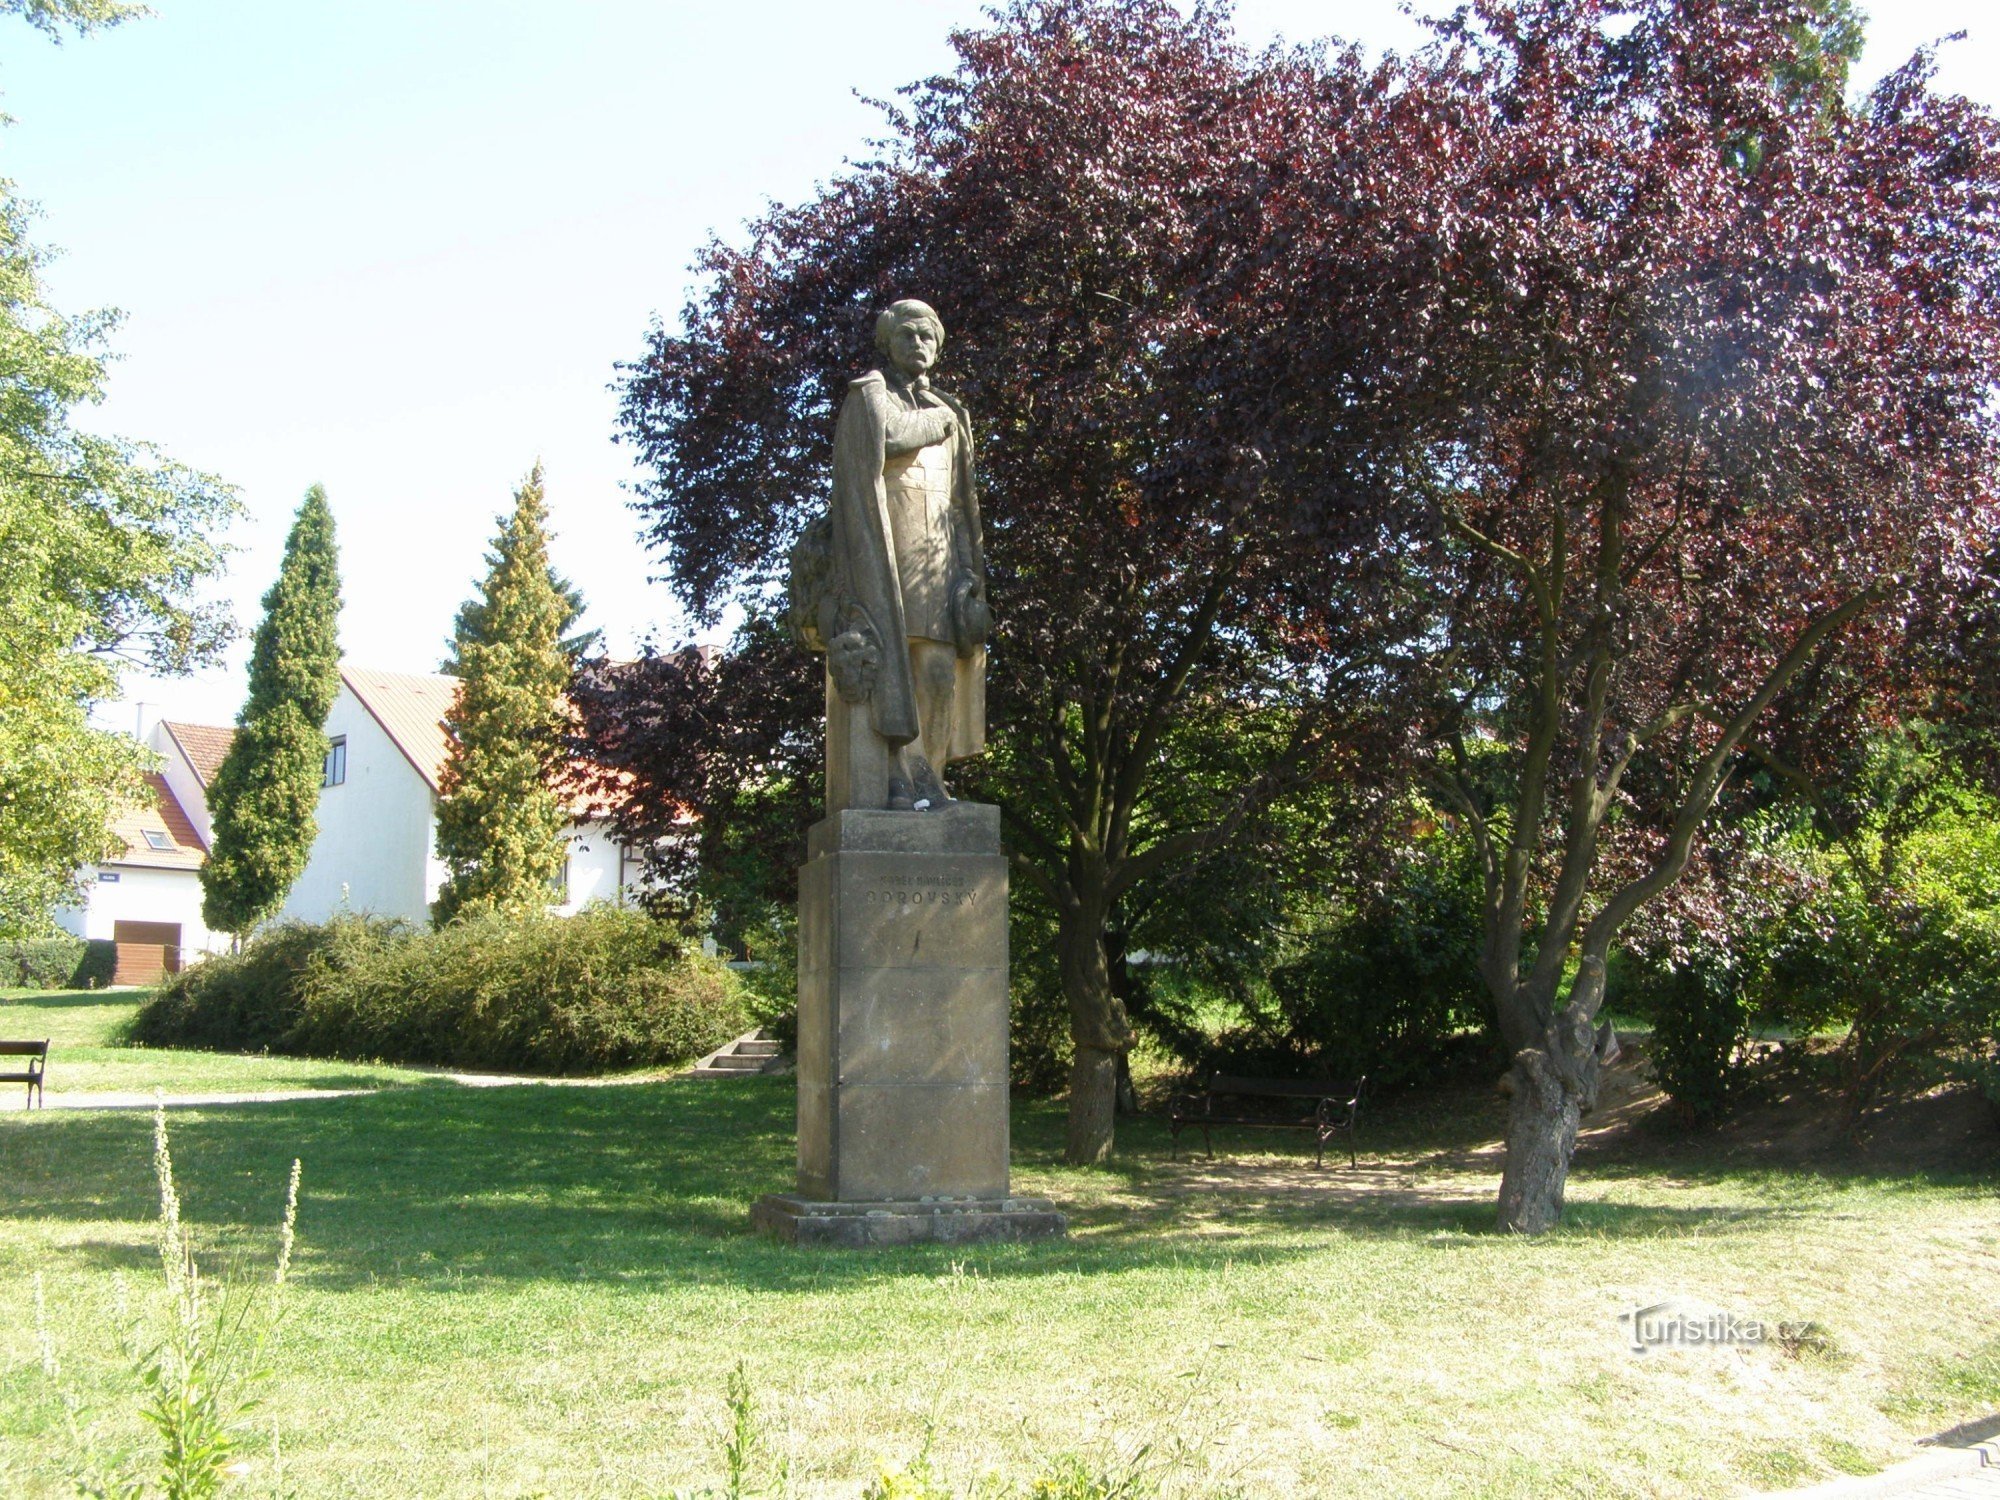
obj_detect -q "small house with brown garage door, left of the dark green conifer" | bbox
[56,720,236,984]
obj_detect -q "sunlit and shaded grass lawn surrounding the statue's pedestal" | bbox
[0,998,2000,1496]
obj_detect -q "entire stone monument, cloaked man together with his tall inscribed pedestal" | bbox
[752,302,1068,1246]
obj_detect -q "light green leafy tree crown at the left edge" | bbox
[0,179,236,934]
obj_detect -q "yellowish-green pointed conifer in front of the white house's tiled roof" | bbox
[432,464,572,922]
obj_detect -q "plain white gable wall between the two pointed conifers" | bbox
[280,684,444,926]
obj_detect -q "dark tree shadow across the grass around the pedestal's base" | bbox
[11,1078,1936,1290]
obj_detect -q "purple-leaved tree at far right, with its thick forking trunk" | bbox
[1256,0,2000,1230]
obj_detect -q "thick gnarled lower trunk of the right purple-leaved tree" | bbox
[1500,988,1618,1234]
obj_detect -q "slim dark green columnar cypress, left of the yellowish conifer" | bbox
[202,484,340,936]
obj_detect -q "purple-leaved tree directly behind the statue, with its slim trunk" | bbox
[584,0,1402,1158]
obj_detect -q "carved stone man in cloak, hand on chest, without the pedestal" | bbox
[792,300,990,812]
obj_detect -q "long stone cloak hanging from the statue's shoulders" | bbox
[828,370,986,762]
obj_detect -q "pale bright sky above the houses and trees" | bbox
[0,0,2000,728]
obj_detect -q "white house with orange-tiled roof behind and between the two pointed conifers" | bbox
[280,666,640,924]
